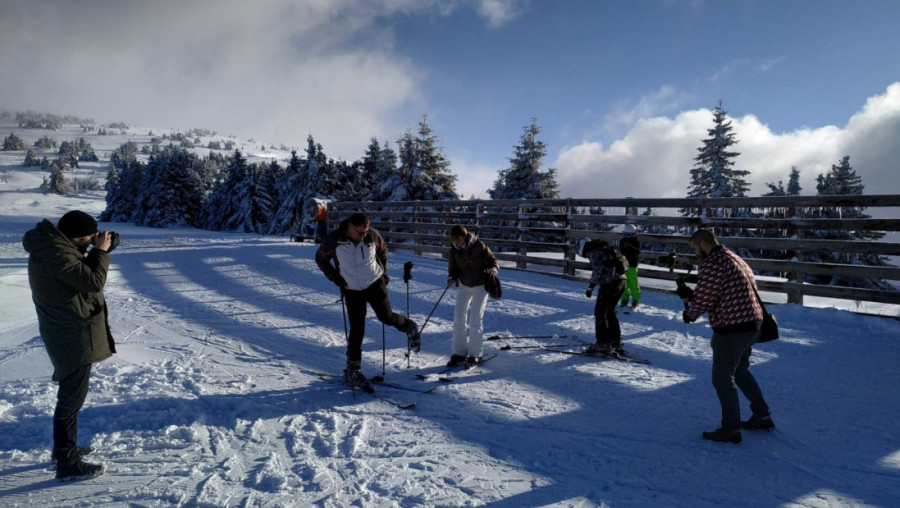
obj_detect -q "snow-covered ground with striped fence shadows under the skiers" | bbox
[0,124,900,508]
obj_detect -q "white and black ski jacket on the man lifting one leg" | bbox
[316,220,387,291]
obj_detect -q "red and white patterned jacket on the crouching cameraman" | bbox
[684,245,762,332]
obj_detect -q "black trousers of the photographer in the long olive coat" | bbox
[53,364,91,464]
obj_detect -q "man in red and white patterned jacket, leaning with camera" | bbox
[683,229,775,444]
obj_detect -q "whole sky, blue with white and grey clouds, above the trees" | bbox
[0,0,900,197]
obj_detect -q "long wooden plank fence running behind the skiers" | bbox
[329,195,900,310]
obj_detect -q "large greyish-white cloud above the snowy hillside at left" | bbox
[0,0,519,160]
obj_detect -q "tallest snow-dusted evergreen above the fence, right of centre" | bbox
[682,101,750,206]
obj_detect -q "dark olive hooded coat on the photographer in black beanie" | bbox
[22,219,116,381]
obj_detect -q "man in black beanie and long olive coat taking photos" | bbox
[22,210,119,481]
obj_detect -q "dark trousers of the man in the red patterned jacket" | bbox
[710,330,769,430]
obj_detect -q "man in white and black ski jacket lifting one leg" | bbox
[316,212,422,391]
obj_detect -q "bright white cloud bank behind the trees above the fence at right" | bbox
[552,83,900,198]
